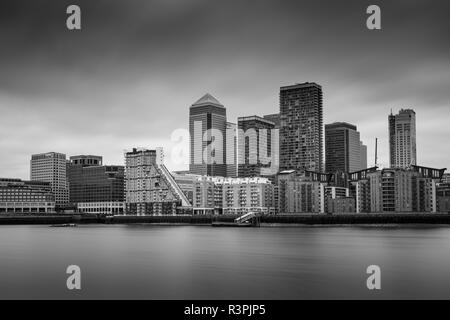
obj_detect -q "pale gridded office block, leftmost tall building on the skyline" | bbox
[30,152,69,207]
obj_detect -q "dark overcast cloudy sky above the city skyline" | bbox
[0,0,450,179]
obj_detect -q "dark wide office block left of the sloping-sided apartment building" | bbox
[67,155,124,214]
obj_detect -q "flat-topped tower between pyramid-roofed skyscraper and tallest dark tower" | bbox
[238,116,279,177]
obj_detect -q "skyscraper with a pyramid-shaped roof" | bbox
[189,93,227,177]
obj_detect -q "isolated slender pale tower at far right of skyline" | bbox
[388,109,417,168]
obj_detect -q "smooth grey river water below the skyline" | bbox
[0,225,450,299]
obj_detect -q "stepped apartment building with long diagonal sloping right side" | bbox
[125,148,191,215]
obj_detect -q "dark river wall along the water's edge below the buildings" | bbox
[0,213,450,226]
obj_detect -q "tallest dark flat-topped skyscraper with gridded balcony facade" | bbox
[280,82,323,172]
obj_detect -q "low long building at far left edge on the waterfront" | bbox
[0,178,55,214]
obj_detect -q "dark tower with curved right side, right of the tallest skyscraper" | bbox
[325,122,367,172]
